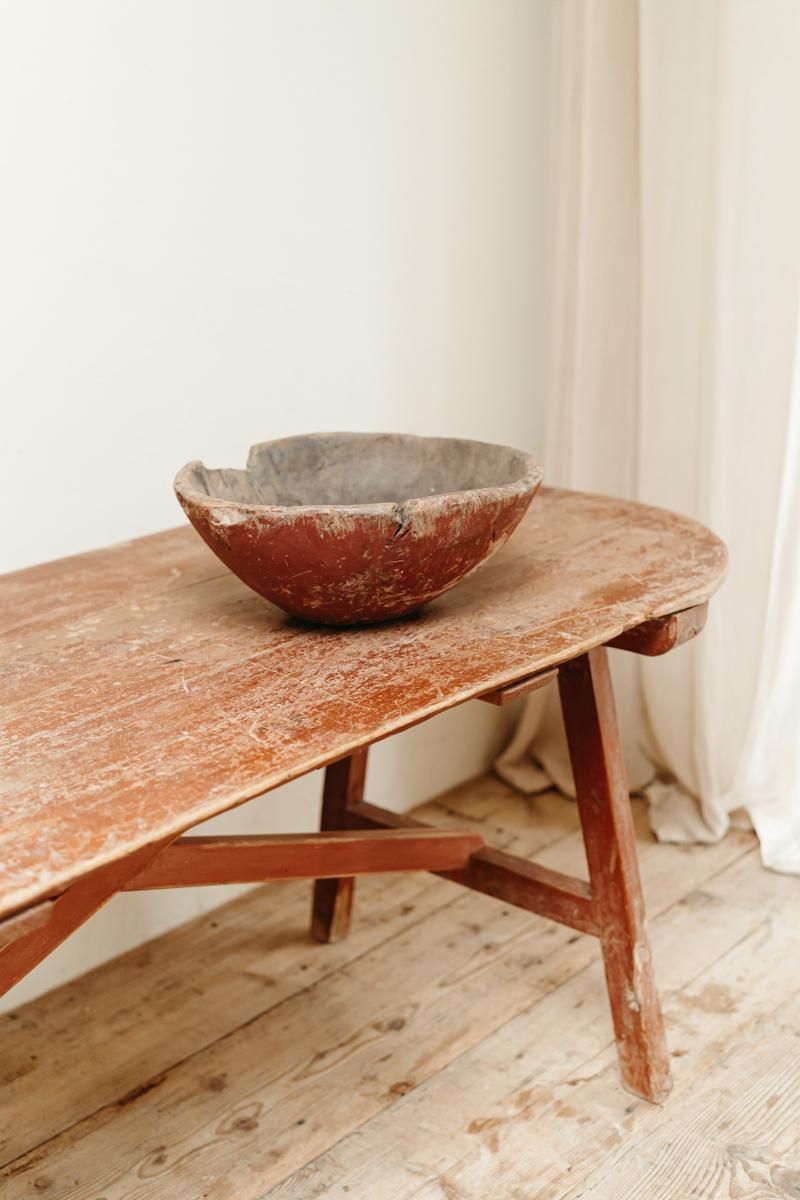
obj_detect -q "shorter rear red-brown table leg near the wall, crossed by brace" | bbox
[311,748,367,942]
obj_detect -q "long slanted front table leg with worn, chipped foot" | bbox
[559,646,672,1102]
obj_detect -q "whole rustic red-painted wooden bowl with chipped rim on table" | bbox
[175,433,542,625]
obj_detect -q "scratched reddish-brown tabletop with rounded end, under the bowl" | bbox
[0,488,726,916]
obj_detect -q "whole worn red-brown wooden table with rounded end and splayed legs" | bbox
[0,488,726,1100]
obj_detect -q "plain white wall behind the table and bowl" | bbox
[0,0,554,1002]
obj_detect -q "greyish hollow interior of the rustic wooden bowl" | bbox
[185,433,533,506]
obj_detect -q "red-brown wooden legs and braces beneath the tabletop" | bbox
[0,605,706,1102]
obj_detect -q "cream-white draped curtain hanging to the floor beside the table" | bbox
[498,0,800,871]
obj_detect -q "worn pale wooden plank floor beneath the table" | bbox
[0,778,800,1200]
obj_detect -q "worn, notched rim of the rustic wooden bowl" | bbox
[173,431,543,516]
